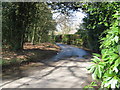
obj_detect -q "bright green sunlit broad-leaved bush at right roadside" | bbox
[89,12,120,88]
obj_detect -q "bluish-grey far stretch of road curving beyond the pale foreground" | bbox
[51,43,88,61]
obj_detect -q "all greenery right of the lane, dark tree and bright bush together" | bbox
[47,2,120,88]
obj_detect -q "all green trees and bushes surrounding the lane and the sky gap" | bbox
[1,2,120,88]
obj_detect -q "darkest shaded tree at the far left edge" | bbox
[2,2,34,50]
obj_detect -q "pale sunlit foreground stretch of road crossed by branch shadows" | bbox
[2,43,92,88]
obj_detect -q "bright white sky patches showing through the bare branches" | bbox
[53,10,86,34]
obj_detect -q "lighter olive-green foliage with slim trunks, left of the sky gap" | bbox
[26,3,55,44]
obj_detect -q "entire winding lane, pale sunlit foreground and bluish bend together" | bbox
[1,44,92,88]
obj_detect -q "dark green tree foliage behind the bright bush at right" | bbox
[78,2,119,52]
